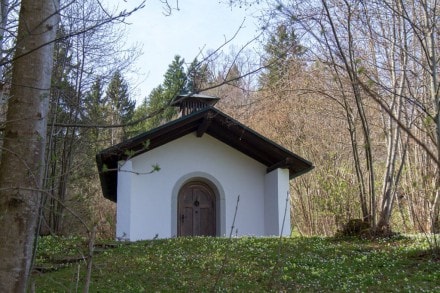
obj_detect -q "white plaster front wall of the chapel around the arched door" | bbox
[117,133,280,241]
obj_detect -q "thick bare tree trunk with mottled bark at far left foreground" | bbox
[0,0,59,292]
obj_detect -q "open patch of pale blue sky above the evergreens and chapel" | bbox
[108,0,259,101]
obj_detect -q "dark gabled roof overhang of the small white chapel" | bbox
[96,107,314,202]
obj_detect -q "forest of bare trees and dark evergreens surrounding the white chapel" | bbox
[0,0,440,291]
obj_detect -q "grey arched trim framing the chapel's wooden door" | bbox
[171,172,226,237]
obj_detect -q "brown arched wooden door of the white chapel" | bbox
[177,182,216,236]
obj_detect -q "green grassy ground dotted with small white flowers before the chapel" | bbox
[32,237,440,292]
